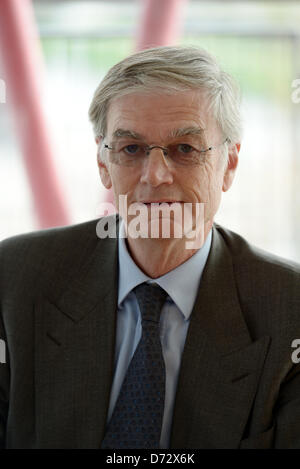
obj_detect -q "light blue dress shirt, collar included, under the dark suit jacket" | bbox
[108,221,212,448]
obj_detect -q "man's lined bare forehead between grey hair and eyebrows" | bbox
[107,90,216,141]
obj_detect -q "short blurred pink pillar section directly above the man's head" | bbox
[137,0,186,50]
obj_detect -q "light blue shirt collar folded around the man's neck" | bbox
[118,220,212,319]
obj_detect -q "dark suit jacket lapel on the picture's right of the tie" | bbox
[171,227,270,449]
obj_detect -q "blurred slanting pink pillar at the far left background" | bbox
[0,0,68,228]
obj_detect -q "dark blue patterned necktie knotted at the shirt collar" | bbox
[101,283,167,449]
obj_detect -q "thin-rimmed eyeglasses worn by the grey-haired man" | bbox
[104,138,229,166]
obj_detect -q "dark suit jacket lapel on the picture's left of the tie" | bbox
[35,216,118,448]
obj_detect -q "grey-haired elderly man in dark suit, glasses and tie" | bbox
[0,47,300,449]
